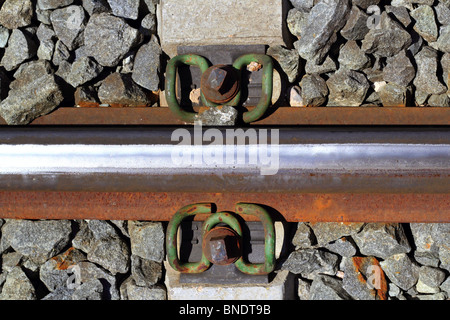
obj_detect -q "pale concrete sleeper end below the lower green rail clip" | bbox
[164,261,294,300]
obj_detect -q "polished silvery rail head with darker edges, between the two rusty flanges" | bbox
[0,127,450,194]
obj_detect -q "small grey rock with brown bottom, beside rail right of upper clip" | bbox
[300,74,328,107]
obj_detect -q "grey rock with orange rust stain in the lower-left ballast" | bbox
[39,247,86,292]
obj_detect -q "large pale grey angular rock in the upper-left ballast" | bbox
[84,13,141,67]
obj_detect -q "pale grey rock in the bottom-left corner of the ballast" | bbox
[0,267,36,300]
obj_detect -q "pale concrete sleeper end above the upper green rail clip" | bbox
[157,0,289,57]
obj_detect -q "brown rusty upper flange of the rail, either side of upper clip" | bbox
[0,107,450,126]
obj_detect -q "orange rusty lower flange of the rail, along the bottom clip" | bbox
[0,191,450,223]
